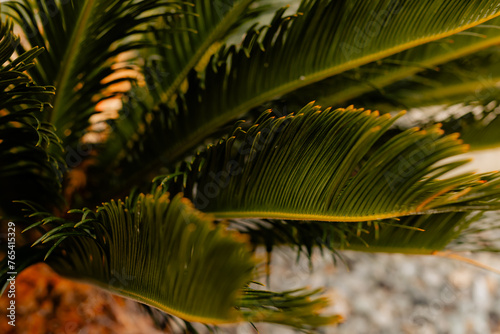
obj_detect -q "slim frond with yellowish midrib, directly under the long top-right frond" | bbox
[286,18,500,107]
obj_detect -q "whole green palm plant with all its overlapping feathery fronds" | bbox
[0,0,500,331]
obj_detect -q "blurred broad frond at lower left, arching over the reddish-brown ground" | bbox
[20,191,338,329]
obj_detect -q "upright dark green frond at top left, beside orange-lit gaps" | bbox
[2,0,180,145]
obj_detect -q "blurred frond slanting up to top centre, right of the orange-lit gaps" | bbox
[101,0,262,180]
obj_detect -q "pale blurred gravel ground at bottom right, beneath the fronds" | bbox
[248,252,500,334]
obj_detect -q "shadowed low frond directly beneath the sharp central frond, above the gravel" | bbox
[234,212,482,259]
